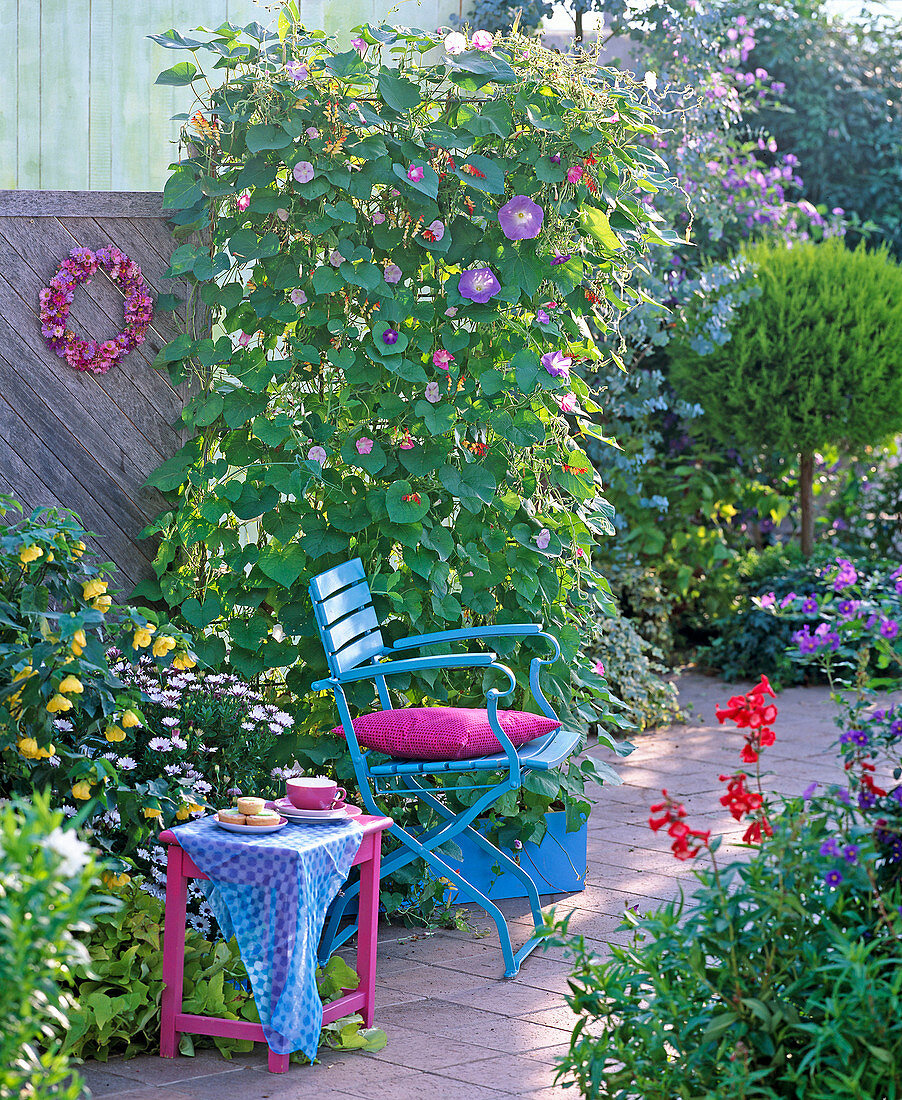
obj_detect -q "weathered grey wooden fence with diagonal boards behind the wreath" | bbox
[0,191,196,593]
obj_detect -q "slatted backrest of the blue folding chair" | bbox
[310,558,387,677]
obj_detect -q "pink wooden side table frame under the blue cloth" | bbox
[160,815,392,1074]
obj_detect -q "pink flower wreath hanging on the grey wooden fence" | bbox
[41,248,154,374]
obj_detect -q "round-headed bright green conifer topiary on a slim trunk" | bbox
[672,239,902,557]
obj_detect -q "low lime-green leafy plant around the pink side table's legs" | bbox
[65,880,385,1062]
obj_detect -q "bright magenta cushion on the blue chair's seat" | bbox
[332,706,561,760]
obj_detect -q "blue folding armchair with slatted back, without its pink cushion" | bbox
[310,558,580,978]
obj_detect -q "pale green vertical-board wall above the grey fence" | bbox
[0,0,451,191]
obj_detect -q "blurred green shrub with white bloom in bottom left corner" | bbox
[0,794,103,1100]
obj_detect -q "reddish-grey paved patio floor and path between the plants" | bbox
[81,672,842,1100]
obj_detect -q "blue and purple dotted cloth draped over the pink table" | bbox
[173,816,363,1060]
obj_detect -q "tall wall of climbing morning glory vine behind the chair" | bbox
[152,15,667,748]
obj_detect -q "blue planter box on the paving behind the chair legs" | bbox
[443,811,589,904]
